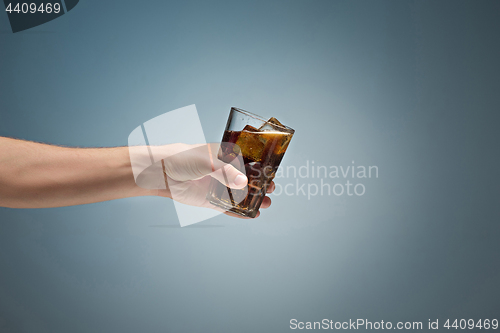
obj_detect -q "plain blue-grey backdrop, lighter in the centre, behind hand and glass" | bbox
[0,0,500,332]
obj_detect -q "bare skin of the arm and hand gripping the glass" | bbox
[0,137,275,218]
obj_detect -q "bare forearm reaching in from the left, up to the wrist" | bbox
[0,138,158,208]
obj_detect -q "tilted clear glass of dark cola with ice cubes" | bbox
[207,107,295,218]
